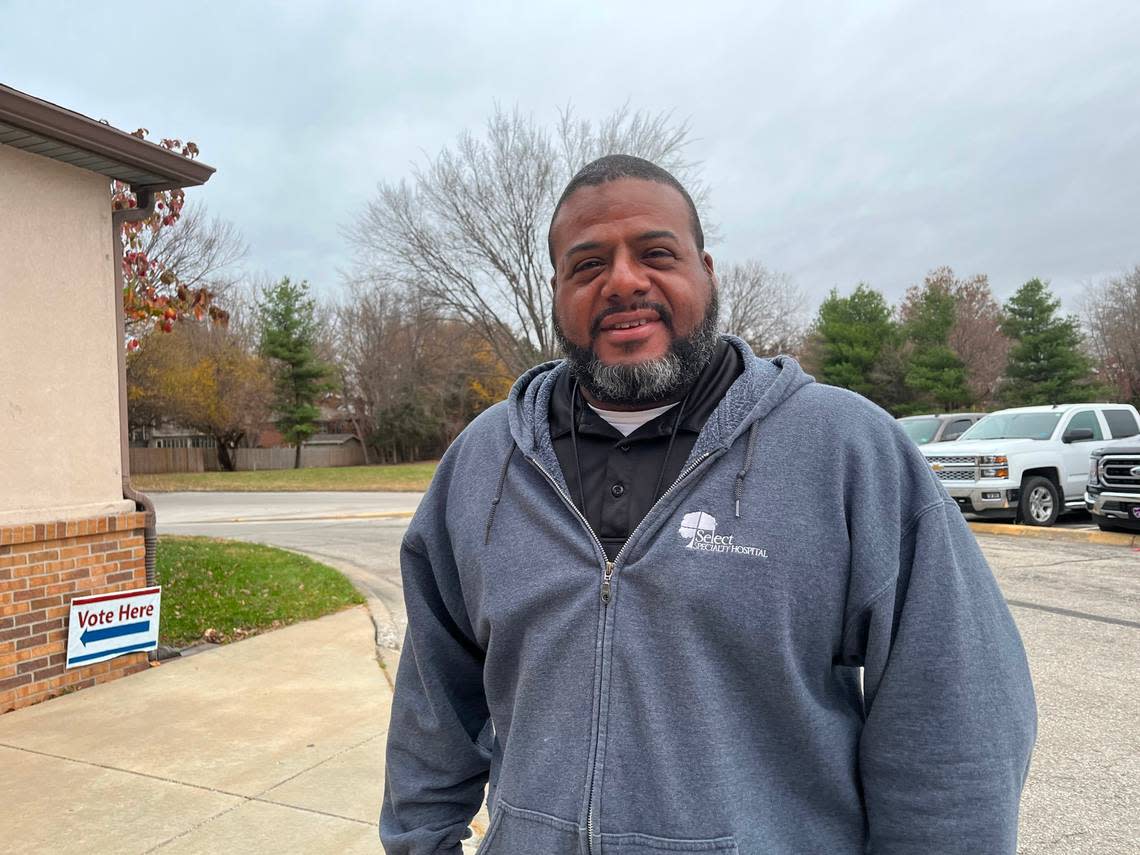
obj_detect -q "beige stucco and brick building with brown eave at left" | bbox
[0,86,213,713]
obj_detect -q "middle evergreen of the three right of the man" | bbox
[904,277,972,413]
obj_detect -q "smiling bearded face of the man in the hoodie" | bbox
[551,178,717,409]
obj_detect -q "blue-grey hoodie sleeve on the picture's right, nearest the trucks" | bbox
[845,499,1036,855]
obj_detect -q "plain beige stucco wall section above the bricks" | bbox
[0,145,135,527]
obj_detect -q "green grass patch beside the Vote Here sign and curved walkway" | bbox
[156,535,364,648]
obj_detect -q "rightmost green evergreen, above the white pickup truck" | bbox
[1001,279,1093,406]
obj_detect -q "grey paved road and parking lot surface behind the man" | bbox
[153,492,1140,855]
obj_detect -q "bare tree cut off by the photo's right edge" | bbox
[1082,264,1140,405]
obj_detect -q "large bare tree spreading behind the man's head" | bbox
[343,106,703,374]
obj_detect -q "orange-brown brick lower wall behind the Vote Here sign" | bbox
[0,513,147,714]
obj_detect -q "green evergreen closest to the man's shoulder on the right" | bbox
[814,283,897,406]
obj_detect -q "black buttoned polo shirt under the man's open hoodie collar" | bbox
[549,340,744,561]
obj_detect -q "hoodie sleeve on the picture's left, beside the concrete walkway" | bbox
[380,540,490,855]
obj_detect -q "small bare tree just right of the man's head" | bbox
[716,260,807,356]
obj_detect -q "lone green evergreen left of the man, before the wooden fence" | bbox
[258,276,334,469]
